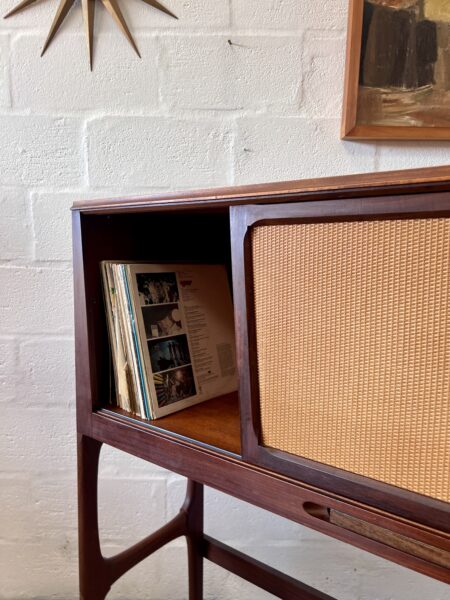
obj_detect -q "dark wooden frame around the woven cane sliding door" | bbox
[231,192,450,532]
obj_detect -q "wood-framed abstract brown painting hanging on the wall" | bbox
[342,0,450,140]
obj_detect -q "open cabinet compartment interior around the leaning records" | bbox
[74,208,241,455]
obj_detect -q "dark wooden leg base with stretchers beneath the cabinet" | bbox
[78,435,334,600]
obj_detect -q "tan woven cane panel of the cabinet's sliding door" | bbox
[236,199,450,528]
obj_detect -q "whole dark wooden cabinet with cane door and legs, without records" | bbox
[73,167,450,600]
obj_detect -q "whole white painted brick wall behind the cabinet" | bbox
[0,0,450,600]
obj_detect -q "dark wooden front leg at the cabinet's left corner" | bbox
[78,434,110,600]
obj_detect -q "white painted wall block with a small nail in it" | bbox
[161,35,301,112]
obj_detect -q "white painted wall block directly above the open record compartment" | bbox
[87,116,232,188]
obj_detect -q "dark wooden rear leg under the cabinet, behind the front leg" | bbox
[183,480,203,600]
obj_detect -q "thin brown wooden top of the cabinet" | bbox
[73,165,450,213]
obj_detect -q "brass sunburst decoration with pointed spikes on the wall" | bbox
[4,0,178,71]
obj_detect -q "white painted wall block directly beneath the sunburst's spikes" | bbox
[11,31,158,114]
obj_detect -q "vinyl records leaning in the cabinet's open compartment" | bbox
[103,262,237,419]
